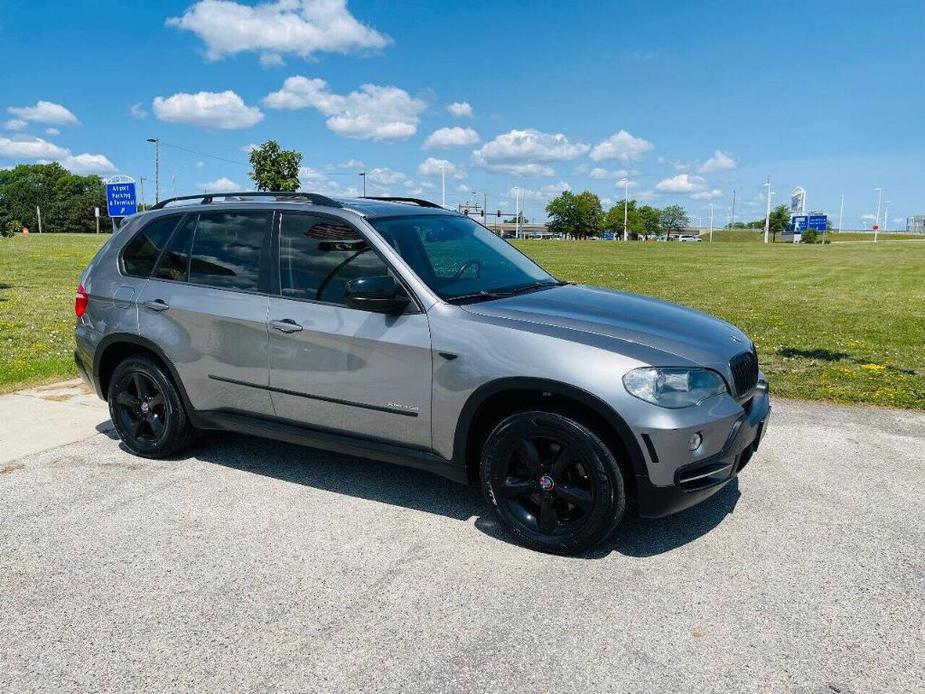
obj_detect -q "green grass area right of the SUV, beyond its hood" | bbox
[517,241,925,409]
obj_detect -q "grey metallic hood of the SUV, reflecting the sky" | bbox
[463,284,752,366]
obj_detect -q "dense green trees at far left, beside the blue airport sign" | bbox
[0,163,112,236]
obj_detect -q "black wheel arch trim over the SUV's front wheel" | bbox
[453,377,648,485]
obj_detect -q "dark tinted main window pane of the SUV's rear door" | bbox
[189,211,273,291]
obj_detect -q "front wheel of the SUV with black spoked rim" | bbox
[480,411,626,554]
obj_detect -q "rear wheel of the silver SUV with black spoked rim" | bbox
[106,356,194,458]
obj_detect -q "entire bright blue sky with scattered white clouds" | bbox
[0,0,925,228]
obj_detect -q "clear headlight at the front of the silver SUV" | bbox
[623,366,729,409]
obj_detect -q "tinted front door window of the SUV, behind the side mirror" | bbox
[279,214,389,305]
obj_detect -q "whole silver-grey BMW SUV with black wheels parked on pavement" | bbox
[75,193,770,554]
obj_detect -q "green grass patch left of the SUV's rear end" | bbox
[0,234,109,392]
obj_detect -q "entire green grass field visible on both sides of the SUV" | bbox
[0,234,925,409]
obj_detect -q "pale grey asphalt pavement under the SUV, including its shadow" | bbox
[0,400,925,693]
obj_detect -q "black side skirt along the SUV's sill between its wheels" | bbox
[191,410,468,484]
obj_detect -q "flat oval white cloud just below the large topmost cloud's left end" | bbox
[153,89,263,130]
